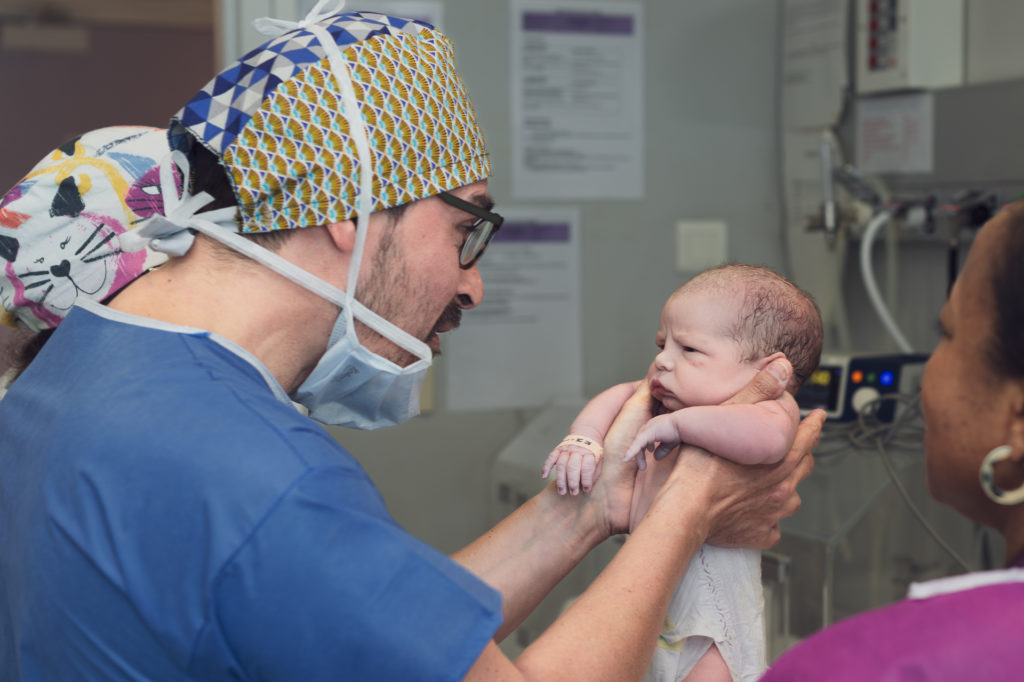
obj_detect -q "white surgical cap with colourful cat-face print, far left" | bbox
[0,126,173,332]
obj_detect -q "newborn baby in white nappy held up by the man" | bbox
[542,265,822,681]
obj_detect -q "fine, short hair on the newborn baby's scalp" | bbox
[673,263,824,393]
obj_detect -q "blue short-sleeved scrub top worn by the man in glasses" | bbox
[0,308,501,681]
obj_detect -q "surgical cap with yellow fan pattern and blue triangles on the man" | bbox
[170,7,489,232]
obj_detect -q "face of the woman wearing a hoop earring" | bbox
[921,217,1010,527]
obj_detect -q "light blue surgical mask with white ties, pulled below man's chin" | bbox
[125,8,432,429]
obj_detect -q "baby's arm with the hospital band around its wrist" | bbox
[541,381,640,495]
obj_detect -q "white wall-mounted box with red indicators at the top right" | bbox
[855,0,965,94]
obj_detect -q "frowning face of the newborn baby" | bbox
[647,288,758,410]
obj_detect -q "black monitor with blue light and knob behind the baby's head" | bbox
[797,353,928,422]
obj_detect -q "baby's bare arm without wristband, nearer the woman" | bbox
[626,393,800,464]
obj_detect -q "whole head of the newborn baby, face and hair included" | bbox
[648,264,822,410]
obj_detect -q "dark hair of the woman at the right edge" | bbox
[984,201,1024,378]
